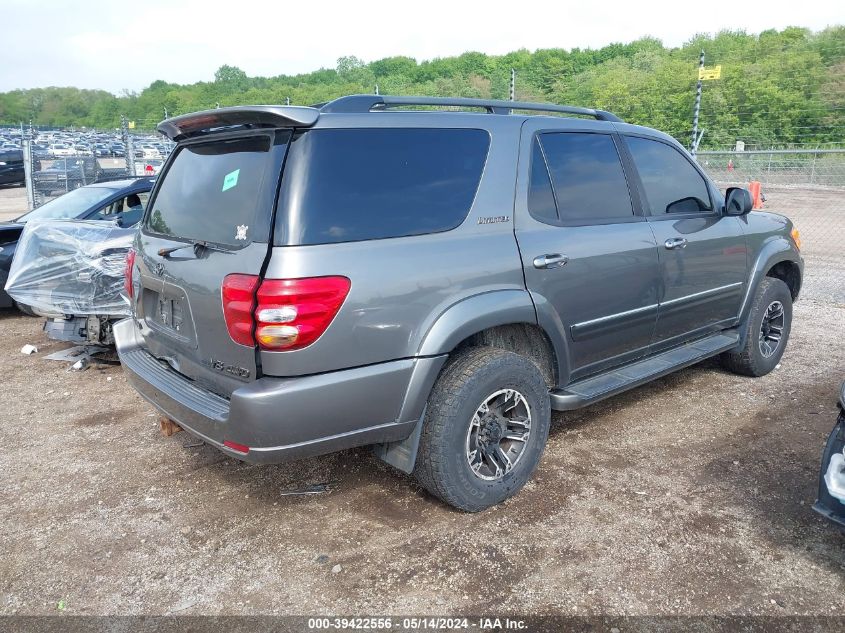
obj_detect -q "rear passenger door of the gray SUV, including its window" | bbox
[515,121,659,385]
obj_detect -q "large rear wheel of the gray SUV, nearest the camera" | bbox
[414,347,551,512]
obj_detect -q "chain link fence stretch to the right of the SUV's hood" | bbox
[697,148,845,304]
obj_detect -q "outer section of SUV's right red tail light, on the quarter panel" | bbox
[255,277,351,350]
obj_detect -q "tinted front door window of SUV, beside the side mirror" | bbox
[625,136,713,215]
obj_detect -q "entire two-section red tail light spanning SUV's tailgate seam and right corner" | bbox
[223,275,351,351]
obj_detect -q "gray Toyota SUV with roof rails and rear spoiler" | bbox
[114,95,803,511]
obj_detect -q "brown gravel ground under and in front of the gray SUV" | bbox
[0,301,845,615]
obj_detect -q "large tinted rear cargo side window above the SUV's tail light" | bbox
[275,128,490,245]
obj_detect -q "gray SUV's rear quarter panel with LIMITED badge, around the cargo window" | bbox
[260,112,533,376]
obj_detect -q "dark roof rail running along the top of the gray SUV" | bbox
[313,95,622,123]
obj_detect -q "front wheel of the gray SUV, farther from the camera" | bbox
[720,277,792,377]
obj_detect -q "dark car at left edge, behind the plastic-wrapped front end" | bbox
[0,178,154,312]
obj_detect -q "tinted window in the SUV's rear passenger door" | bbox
[532,132,634,224]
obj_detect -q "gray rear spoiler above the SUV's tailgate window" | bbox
[156,106,320,141]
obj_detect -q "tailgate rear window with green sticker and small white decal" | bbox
[144,136,277,246]
